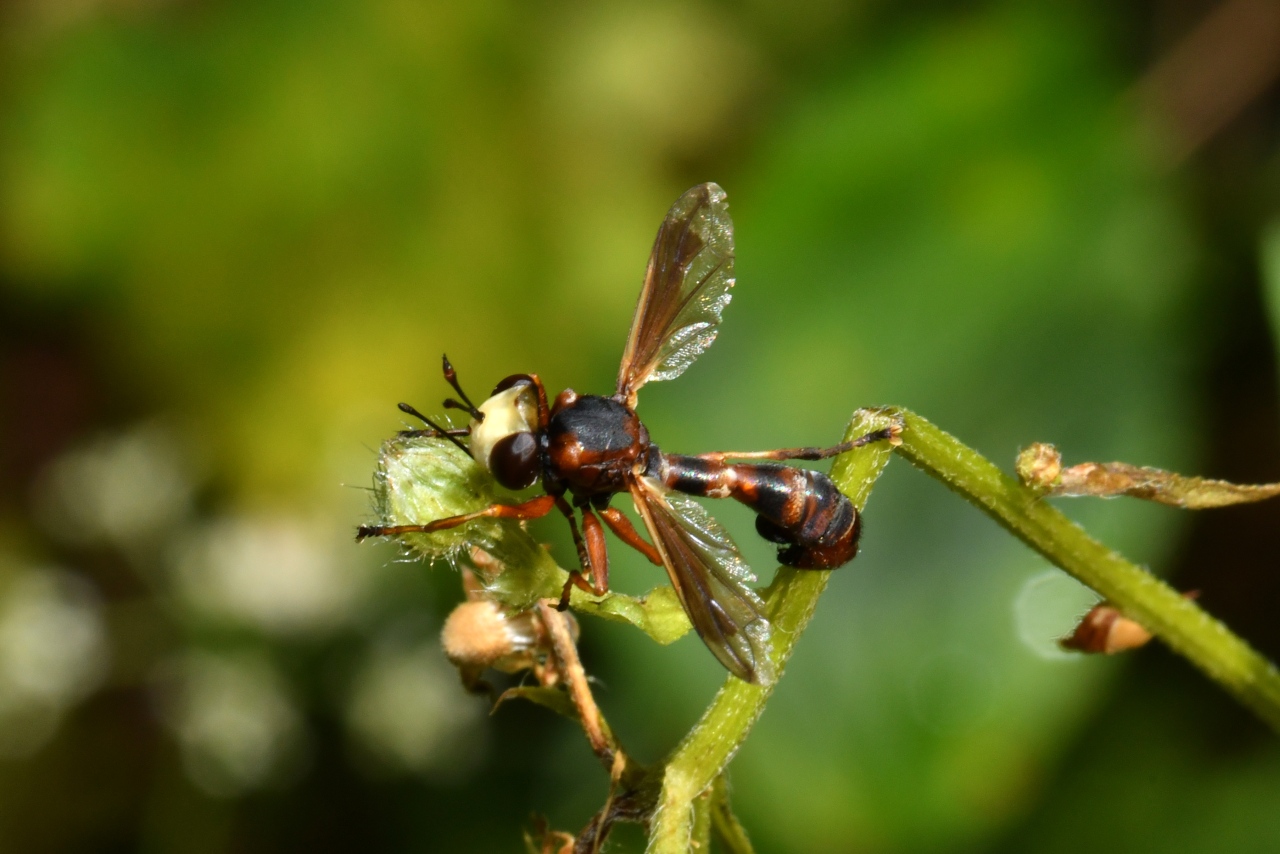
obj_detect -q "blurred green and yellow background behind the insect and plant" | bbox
[0,0,1280,854]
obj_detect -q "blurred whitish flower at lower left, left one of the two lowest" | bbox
[165,653,305,796]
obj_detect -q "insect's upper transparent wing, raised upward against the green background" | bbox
[618,184,733,406]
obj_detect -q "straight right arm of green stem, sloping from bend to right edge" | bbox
[897,410,1280,730]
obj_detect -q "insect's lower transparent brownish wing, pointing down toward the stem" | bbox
[631,478,774,685]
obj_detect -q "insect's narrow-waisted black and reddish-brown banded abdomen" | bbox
[663,453,861,570]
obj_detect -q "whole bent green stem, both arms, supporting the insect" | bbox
[646,407,1280,854]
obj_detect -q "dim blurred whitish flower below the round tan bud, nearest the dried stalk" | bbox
[347,639,484,780]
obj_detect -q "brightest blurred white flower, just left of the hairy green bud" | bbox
[175,516,364,634]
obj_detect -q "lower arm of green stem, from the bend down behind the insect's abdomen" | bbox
[646,410,895,854]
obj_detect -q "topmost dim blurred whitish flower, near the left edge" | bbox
[35,423,192,549]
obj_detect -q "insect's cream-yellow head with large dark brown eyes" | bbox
[471,382,540,489]
